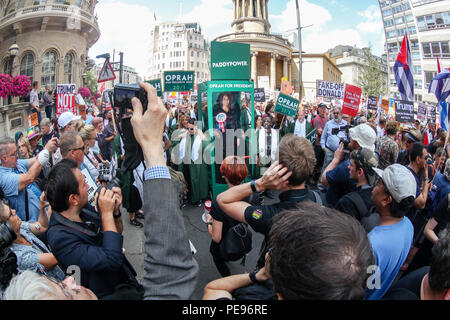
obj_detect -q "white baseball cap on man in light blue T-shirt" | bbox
[373,163,417,203]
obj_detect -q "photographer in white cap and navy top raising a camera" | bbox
[321,124,377,207]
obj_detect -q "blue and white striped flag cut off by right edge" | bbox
[428,69,450,131]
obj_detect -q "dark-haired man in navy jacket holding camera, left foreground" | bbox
[46,159,143,299]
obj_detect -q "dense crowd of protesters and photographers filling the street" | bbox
[0,80,450,300]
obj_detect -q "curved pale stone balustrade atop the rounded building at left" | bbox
[0,4,98,28]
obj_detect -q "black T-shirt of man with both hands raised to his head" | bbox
[245,189,324,236]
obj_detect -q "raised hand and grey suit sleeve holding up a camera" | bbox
[131,83,198,300]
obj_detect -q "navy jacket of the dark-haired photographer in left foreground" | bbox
[47,210,138,298]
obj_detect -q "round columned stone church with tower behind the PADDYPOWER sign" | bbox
[214,0,293,90]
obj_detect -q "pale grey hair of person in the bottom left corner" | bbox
[3,270,58,300]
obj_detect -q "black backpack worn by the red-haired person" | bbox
[219,222,252,261]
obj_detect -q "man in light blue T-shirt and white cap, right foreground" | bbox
[366,164,416,300]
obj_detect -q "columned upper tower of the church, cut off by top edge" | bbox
[232,0,270,33]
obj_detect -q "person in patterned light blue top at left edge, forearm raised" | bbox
[0,193,65,280]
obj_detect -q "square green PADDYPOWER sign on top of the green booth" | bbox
[211,42,250,81]
